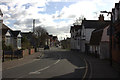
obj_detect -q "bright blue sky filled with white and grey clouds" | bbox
[0,0,119,40]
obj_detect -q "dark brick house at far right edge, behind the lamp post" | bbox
[112,1,120,71]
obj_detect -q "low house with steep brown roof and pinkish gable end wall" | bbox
[89,25,110,59]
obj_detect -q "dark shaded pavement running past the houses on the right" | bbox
[77,53,120,80]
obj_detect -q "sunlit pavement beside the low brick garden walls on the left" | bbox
[2,50,44,70]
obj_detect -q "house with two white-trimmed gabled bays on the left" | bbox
[2,24,22,50]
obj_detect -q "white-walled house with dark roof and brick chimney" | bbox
[80,14,110,52]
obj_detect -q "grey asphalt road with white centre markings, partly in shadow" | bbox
[3,48,87,80]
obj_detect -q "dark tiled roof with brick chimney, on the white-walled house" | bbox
[82,20,110,29]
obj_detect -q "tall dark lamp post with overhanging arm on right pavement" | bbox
[100,11,113,66]
